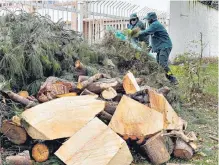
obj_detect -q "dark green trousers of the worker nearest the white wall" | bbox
[156,48,172,74]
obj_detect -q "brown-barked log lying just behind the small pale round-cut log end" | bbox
[87,78,123,94]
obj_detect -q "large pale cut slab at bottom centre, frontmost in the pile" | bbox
[55,118,132,165]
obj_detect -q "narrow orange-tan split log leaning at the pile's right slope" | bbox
[148,89,181,129]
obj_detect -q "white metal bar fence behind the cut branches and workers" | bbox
[0,0,166,43]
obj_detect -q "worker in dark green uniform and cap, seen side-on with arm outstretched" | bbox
[137,12,178,84]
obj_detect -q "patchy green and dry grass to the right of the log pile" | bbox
[133,63,218,165]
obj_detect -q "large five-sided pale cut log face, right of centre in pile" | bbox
[109,96,163,139]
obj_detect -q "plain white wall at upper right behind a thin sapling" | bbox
[169,1,218,60]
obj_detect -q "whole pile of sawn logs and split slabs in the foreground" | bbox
[1,61,197,165]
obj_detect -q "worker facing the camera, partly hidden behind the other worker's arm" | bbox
[128,13,149,45]
